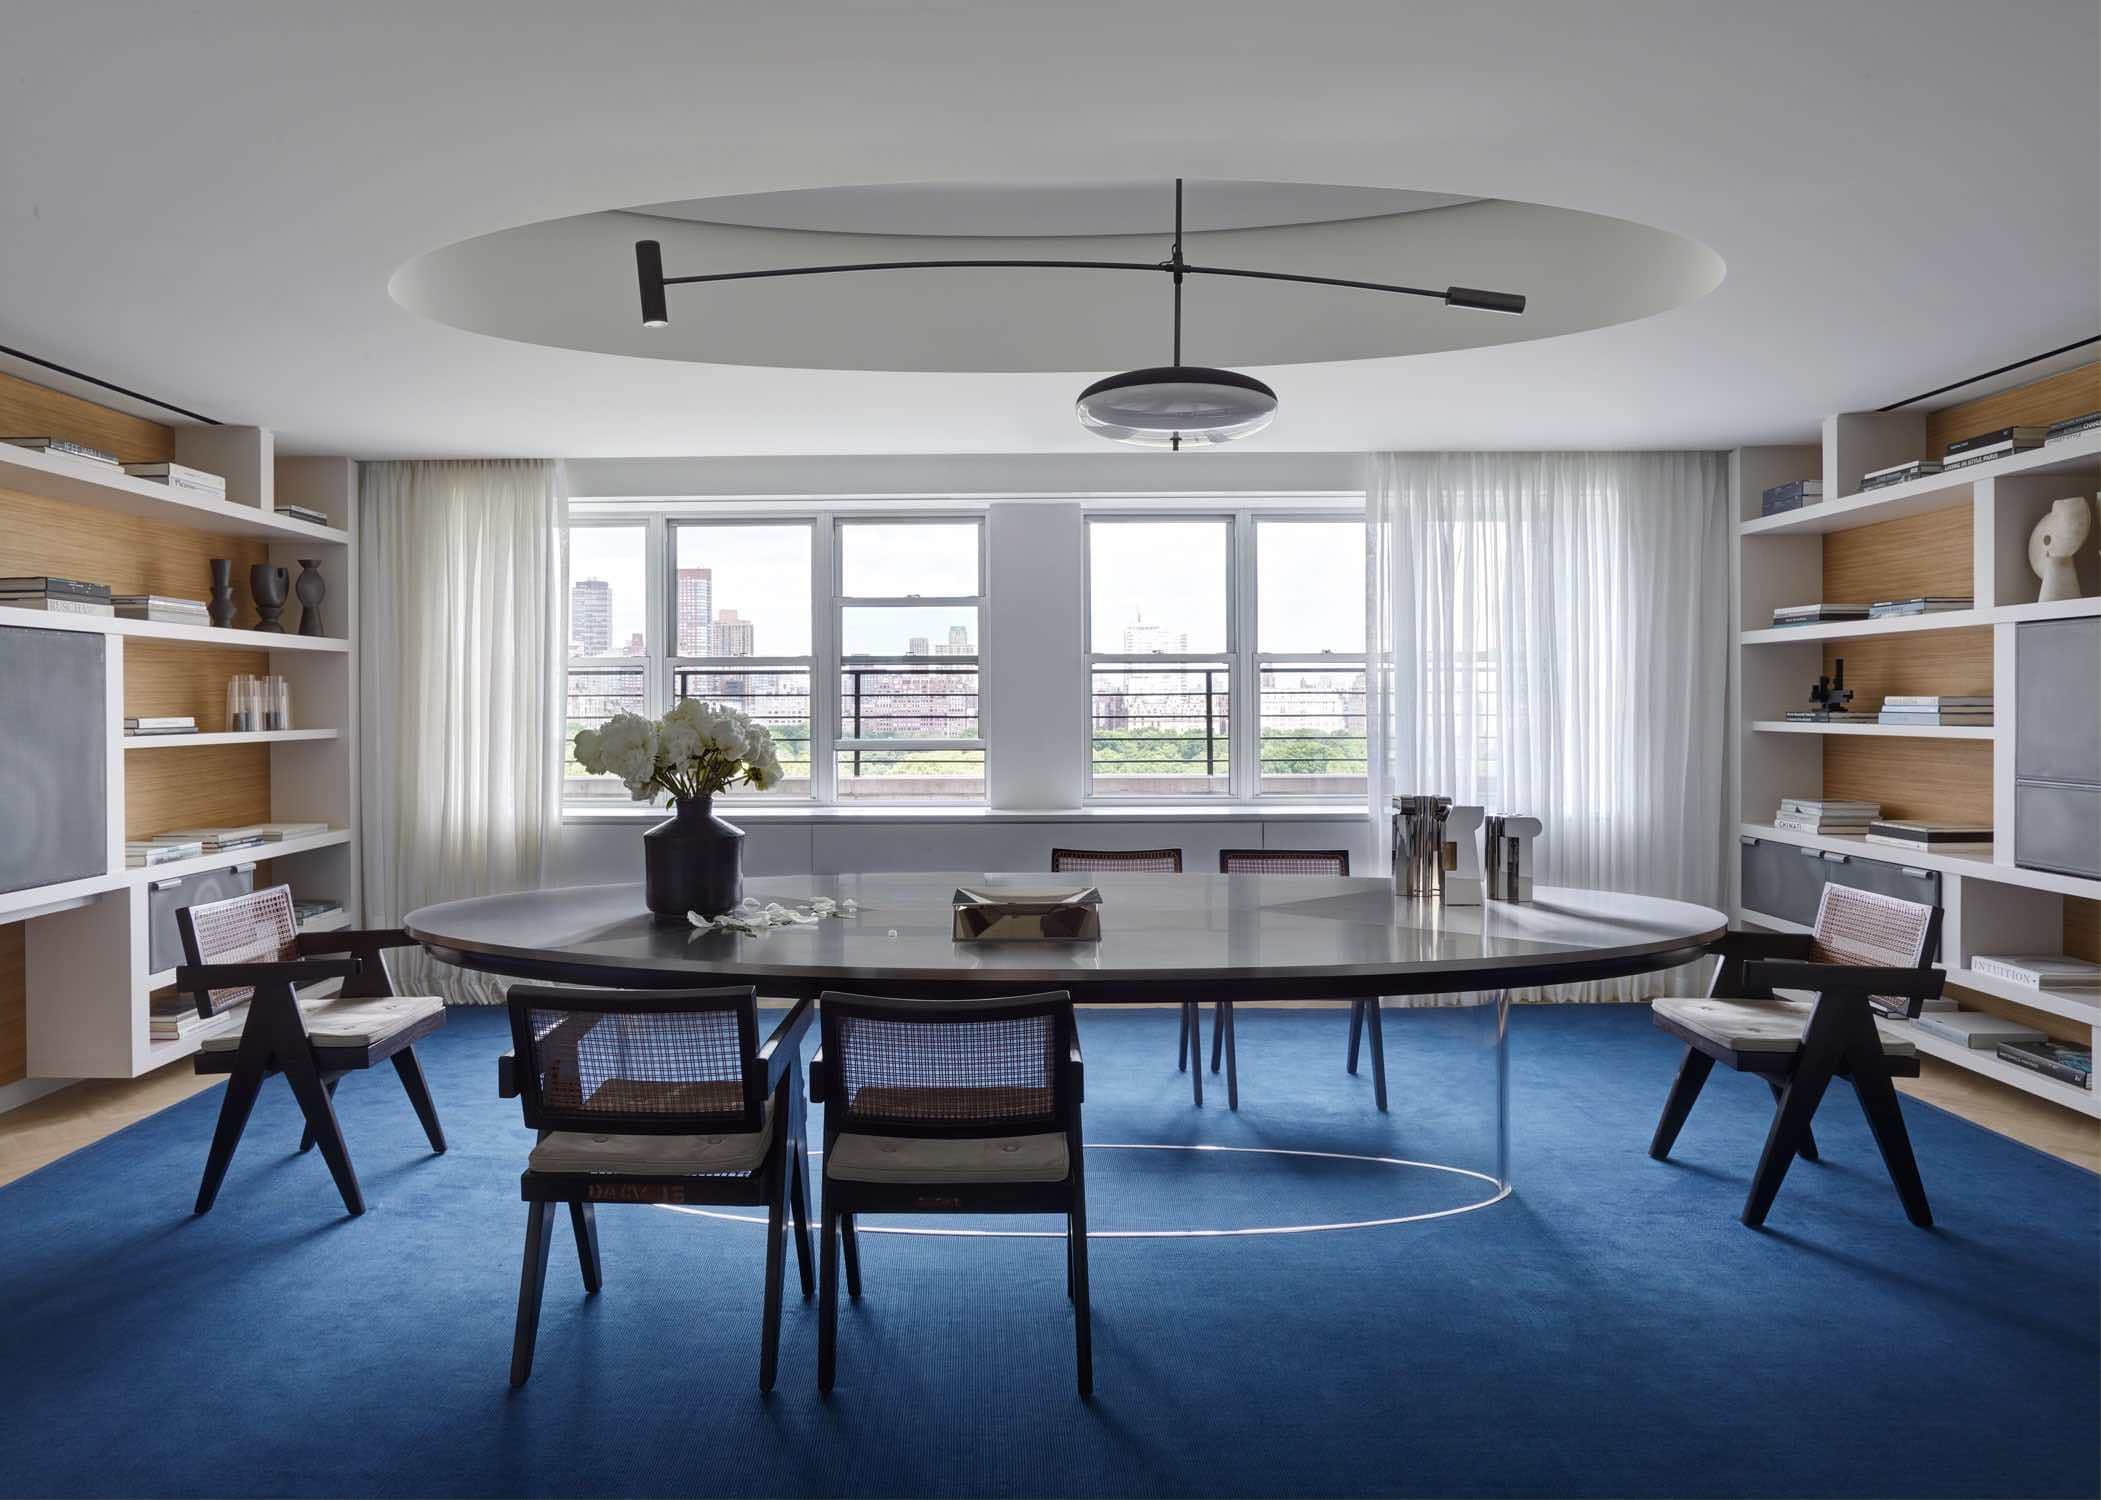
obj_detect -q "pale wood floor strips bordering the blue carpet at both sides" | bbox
[0,1029,2101,1185]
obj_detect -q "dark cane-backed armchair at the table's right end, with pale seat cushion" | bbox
[1649,884,1946,1229]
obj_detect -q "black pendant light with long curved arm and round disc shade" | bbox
[635,176,1525,450]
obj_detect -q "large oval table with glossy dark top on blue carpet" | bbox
[403,872,1729,1201]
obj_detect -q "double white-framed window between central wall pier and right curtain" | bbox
[1086,511,1366,800]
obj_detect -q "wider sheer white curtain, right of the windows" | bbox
[1366,454,1729,994]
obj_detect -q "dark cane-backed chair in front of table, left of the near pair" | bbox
[498,985,815,1391]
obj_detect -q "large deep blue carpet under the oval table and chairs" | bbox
[0,1006,2101,1496]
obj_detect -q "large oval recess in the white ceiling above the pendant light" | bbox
[391,181,1723,374]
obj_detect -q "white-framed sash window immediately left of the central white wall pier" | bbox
[834,517,985,803]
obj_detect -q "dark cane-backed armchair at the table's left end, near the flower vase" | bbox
[174,884,445,1214]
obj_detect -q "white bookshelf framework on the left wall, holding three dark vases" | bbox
[0,439,359,1080]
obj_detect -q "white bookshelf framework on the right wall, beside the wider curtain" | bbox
[1729,412,2101,1118]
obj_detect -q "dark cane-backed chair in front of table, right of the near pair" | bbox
[809,992,1095,1395]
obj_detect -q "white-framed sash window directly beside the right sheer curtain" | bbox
[1254,517,1368,798]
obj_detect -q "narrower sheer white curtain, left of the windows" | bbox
[357,460,563,1000]
